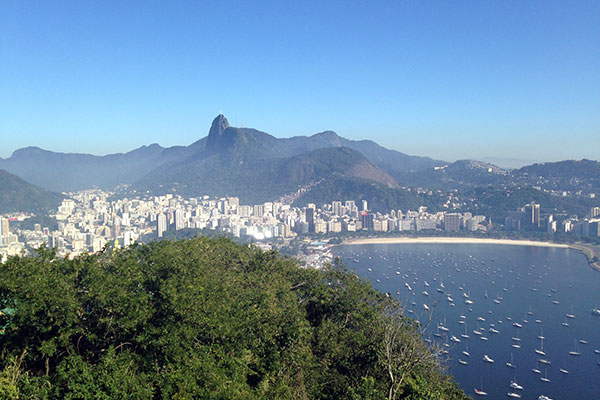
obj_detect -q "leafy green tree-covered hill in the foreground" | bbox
[0,238,466,399]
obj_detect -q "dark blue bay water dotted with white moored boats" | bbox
[334,244,600,400]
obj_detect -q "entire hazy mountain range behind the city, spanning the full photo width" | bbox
[0,115,600,211]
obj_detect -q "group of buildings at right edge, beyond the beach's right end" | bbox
[504,202,600,237]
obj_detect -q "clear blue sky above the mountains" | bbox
[0,0,600,165]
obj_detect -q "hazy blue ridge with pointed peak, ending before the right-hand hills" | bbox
[0,114,443,198]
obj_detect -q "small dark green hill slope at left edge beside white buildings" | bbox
[0,169,63,214]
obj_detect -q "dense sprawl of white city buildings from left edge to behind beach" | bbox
[0,190,487,258]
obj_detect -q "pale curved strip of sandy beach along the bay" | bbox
[342,237,569,248]
